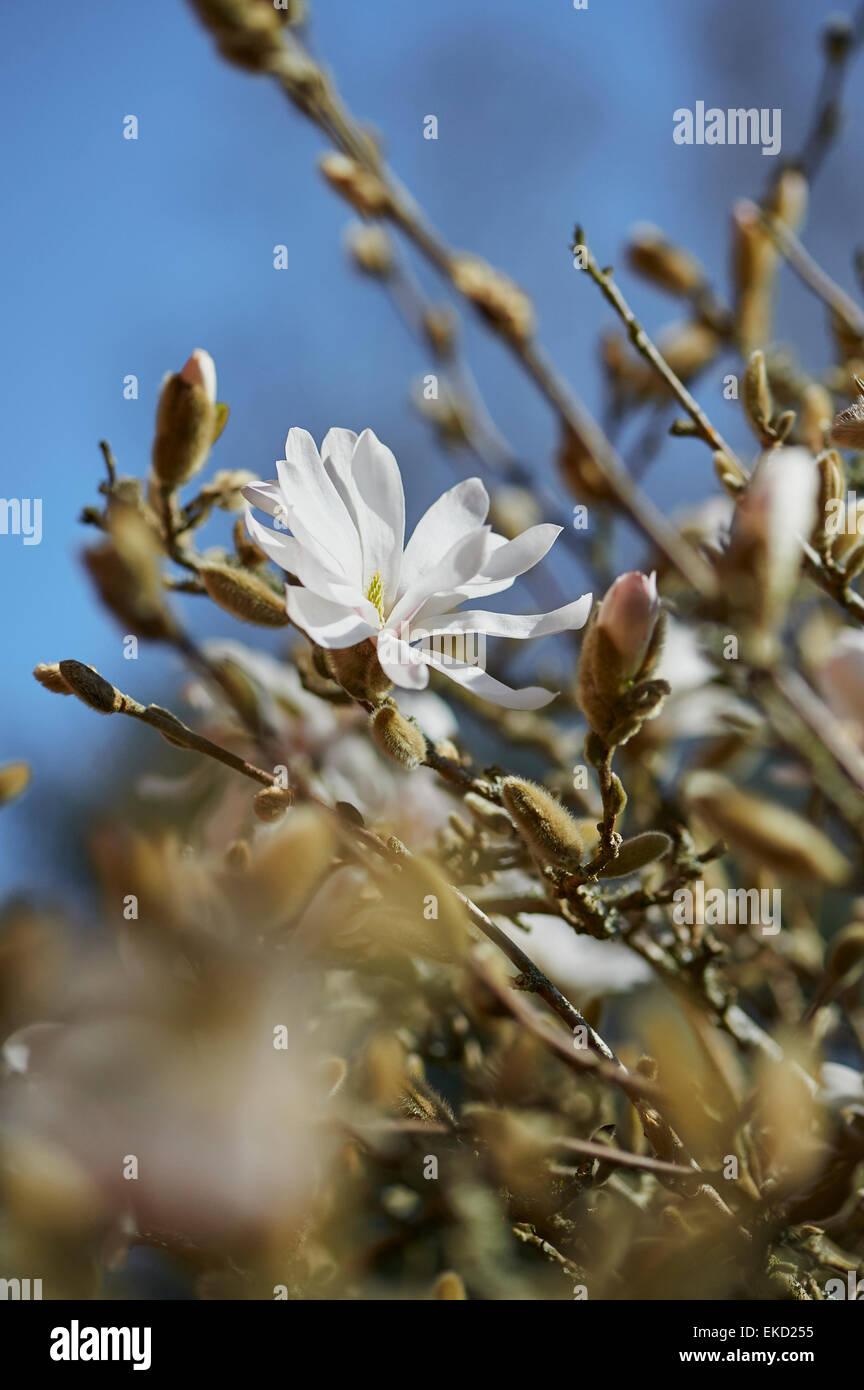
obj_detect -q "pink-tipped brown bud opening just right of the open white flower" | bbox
[579,570,668,745]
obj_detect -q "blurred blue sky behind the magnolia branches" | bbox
[0,0,864,905]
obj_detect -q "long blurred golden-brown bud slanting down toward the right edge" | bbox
[685,771,850,884]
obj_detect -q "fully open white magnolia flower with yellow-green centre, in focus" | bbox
[243,430,592,709]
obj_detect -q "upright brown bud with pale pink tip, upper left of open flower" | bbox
[153,348,224,488]
